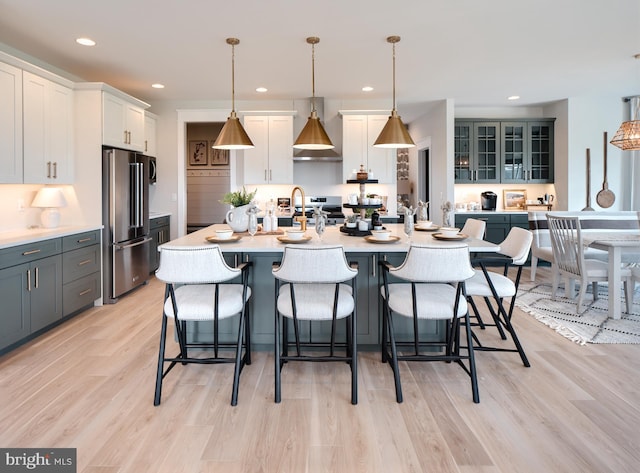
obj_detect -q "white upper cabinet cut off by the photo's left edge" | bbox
[0,62,22,184]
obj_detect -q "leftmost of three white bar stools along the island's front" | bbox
[153,245,252,406]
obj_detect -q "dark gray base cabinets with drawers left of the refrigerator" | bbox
[0,229,101,354]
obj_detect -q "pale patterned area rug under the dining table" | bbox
[516,277,640,345]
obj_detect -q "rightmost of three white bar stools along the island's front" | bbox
[379,243,480,403]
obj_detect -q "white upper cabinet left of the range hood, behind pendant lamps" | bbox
[244,116,293,184]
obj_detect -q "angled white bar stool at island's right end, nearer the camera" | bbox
[466,227,533,367]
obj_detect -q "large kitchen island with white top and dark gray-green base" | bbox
[159,224,499,349]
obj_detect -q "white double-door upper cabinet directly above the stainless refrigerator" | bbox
[102,92,145,152]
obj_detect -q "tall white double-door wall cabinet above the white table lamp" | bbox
[22,71,74,184]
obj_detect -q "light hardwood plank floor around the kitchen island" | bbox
[0,269,640,473]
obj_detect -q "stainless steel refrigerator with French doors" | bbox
[102,148,151,304]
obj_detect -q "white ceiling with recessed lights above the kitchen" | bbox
[0,0,640,121]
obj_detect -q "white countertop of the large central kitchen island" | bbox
[159,224,500,253]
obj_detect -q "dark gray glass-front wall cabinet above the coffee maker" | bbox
[454,119,554,184]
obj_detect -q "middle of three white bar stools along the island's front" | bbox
[272,245,358,404]
